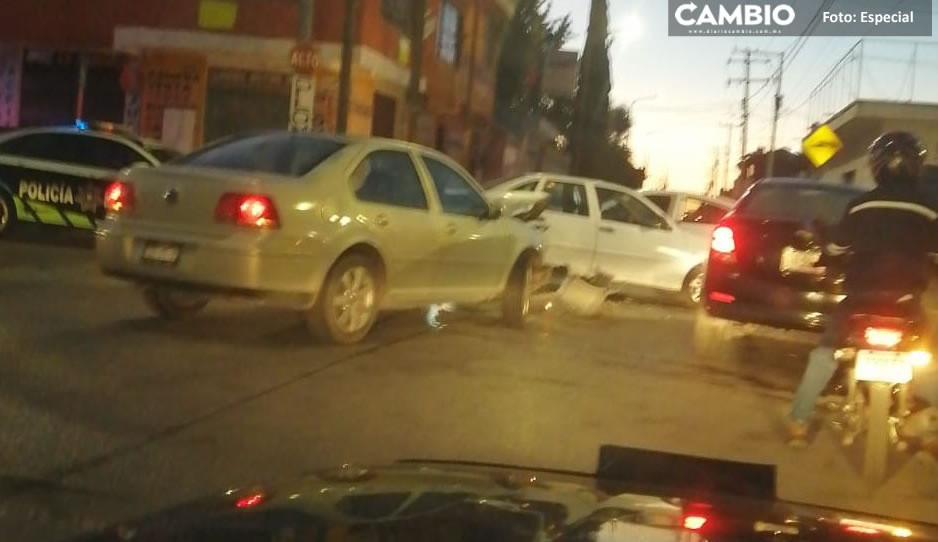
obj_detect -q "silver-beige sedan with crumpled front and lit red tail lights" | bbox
[97,132,544,344]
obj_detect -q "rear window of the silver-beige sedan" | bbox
[172,133,345,177]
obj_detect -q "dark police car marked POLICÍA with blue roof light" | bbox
[0,122,177,237]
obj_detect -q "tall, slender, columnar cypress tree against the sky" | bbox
[570,0,612,176]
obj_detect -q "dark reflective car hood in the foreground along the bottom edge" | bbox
[69,446,938,542]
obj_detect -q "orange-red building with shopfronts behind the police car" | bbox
[0,0,516,170]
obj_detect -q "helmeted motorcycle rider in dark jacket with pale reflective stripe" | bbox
[789,132,938,445]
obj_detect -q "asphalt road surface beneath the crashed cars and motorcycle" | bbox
[0,232,938,540]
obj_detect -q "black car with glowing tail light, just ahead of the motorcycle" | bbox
[694,179,863,359]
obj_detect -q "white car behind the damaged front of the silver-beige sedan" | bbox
[490,173,710,304]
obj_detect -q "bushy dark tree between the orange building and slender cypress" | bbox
[495,0,570,117]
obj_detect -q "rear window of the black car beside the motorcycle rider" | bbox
[736,184,859,224]
